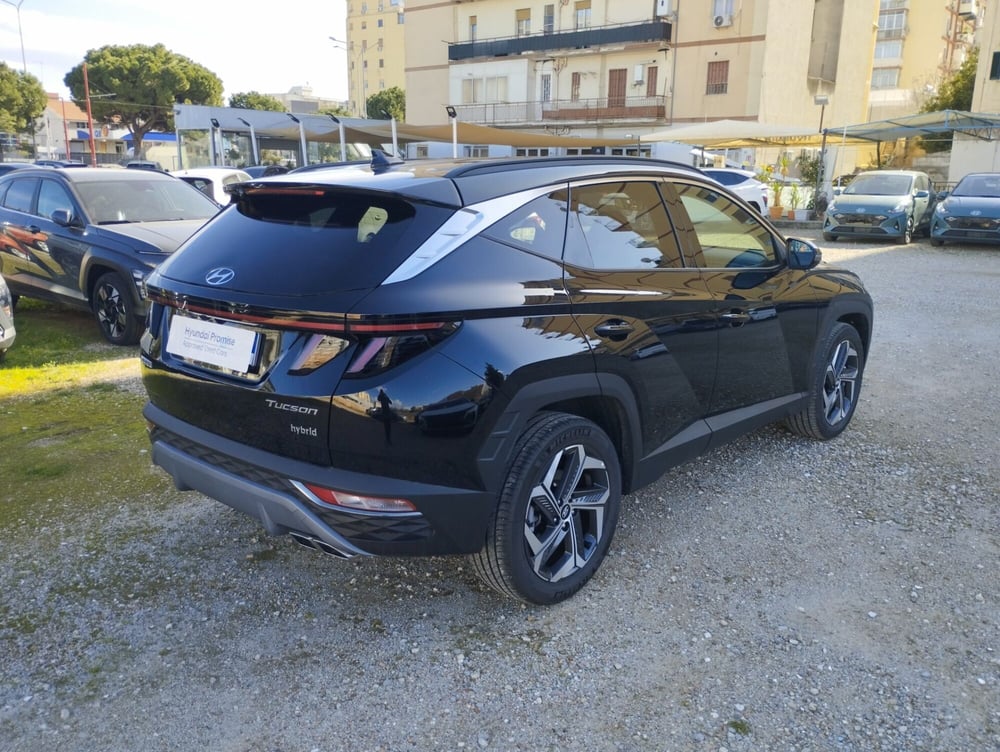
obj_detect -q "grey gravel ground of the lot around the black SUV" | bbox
[0,231,1000,752]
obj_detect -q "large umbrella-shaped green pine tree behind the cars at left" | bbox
[63,44,222,157]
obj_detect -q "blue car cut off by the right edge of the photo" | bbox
[931,172,1000,246]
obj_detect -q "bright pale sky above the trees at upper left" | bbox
[0,0,347,104]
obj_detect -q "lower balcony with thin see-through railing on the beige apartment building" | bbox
[455,96,667,126]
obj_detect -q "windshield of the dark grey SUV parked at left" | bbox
[77,179,219,225]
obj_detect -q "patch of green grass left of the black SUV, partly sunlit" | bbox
[0,298,171,530]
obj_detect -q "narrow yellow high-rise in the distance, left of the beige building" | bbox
[344,0,406,118]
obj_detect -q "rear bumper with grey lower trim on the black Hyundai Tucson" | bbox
[143,403,496,557]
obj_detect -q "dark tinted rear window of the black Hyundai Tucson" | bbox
[161,184,454,295]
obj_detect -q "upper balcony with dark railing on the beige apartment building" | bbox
[448,20,670,62]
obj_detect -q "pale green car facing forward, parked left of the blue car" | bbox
[823,170,936,243]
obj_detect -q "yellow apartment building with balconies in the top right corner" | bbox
[872,0,986,122]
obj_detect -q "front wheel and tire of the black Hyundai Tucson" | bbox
[785,322,865,440]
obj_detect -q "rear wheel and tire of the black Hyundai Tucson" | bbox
[470,413,621,605]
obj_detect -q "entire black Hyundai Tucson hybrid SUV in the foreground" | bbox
[141,156,872,604]
